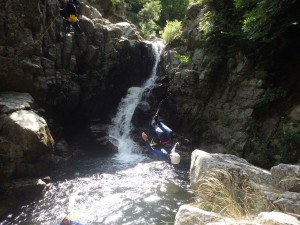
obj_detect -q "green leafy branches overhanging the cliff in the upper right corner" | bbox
[197,0,300,45]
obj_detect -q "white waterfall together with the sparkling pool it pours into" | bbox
[0,41,192,225]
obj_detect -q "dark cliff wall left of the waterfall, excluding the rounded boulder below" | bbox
[0,1,153,119]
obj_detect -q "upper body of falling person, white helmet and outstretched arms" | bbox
[142,132,180,164]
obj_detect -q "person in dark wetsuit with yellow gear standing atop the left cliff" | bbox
[60,0,82,34]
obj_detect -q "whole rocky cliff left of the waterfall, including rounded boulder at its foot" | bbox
[0,0,154,206]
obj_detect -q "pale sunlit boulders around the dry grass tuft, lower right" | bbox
[175,150,300,225]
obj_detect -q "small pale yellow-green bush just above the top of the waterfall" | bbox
[161,20,182,43]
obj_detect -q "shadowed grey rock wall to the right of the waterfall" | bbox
[160,3,300,168]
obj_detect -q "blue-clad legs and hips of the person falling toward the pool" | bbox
[150,113,173,148]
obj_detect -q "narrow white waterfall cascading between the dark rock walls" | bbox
[109,42,164,162]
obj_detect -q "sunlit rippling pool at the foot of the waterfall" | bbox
[3,157,191,225]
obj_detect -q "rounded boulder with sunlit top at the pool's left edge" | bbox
[0,92,54,185]
